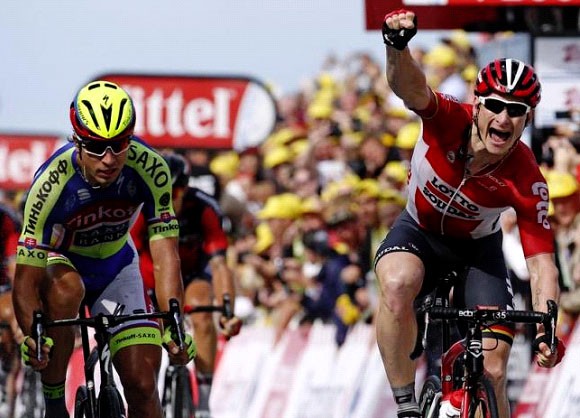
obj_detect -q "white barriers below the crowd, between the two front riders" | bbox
[210,324,404,418]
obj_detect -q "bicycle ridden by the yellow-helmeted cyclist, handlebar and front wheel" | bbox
[32,299,184,418]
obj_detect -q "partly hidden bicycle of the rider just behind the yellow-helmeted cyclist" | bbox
[161,293,233,418]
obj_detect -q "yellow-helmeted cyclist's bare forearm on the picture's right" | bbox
[149,238,183,311]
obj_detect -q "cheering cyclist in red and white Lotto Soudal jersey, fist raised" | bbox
[375,10,564,418]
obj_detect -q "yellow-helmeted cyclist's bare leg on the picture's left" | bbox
[41,254,85,418]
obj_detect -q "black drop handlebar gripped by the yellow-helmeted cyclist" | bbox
[31,298,185,361]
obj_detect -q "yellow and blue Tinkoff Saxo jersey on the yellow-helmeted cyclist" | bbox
[17,138,179,289]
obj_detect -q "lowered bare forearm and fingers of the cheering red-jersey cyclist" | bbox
[526,253,559,367]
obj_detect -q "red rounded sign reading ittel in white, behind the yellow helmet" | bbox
[99,74,276,149]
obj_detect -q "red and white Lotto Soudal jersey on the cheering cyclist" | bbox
[407,93,554,257]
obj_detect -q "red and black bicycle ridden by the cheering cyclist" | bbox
[411,271,558,418]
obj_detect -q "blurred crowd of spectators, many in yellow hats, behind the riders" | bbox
[3,31,580,398]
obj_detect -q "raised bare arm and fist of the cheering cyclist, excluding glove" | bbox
[385,12,433,110]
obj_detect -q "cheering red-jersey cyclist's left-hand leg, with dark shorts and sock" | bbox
[375,212,426,417]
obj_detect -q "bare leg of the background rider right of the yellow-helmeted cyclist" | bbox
[185,279,217,413]
